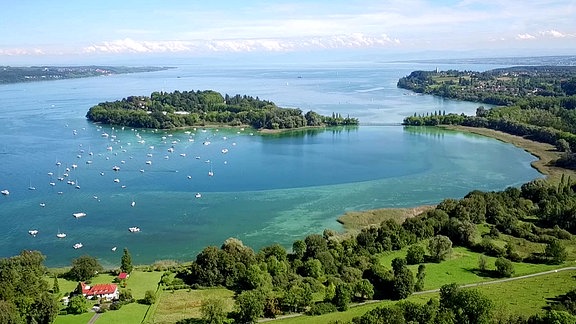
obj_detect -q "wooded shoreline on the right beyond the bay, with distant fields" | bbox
[398,66,576,169]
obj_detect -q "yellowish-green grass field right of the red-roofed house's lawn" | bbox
[153,288,234,324]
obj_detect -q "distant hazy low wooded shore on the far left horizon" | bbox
[0,66,168,84]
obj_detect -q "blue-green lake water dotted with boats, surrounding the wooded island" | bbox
[0,64,541,266]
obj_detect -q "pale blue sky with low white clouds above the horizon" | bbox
[0,0,576,65]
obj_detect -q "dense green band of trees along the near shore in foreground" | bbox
[177,179,576,323]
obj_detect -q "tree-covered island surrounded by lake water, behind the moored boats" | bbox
[86,90,358,129]
